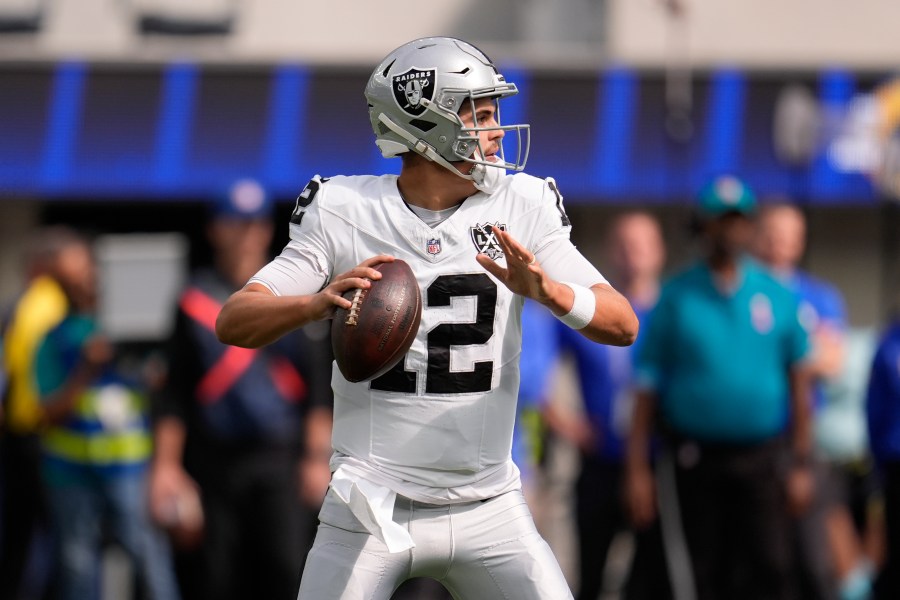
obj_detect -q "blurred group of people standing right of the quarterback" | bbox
[520,176,900,600]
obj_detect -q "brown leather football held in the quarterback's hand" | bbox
[331,259,422,382]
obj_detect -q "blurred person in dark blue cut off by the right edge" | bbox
[866,317,900,600]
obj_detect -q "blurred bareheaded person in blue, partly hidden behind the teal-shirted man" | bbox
[754,203,870,600]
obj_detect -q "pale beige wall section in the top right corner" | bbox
[608,0,900,69]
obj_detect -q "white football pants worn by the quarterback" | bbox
[298,490,572,600]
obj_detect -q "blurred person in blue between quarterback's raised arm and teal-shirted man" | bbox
[522,212,669,600]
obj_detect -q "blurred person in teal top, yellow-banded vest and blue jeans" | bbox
[35,231,178,600]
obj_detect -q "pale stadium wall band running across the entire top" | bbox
[0,0,900,69]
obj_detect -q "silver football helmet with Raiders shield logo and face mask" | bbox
[366,37,530,183]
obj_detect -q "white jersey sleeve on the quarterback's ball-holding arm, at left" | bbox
[249,175,333,296]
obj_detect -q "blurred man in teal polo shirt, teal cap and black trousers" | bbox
[626,176,814,600]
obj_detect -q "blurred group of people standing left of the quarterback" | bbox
[0,180,331,600]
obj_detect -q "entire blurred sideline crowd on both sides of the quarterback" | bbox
[0,176,900,600]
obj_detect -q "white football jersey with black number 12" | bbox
[251,174,606,503]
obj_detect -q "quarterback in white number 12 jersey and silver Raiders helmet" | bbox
[217,37,638,600]
